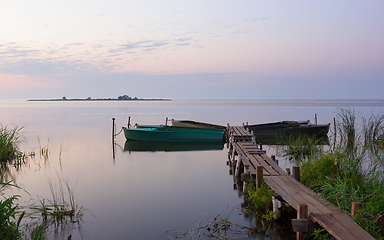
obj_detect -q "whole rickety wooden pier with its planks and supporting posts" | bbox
[228,126,374,240]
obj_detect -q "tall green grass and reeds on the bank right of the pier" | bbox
[294,109,384,239]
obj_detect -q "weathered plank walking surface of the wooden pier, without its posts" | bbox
[230,127,374,240]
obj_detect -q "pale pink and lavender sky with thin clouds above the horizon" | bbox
[0,0,384,99]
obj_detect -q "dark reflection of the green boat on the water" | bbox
[124,140,224,152]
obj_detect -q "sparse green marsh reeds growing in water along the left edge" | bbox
[0,126,87,240]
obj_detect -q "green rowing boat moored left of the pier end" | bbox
[123,125,224,143]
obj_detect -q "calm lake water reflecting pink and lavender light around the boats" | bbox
[0,99,384,240]
